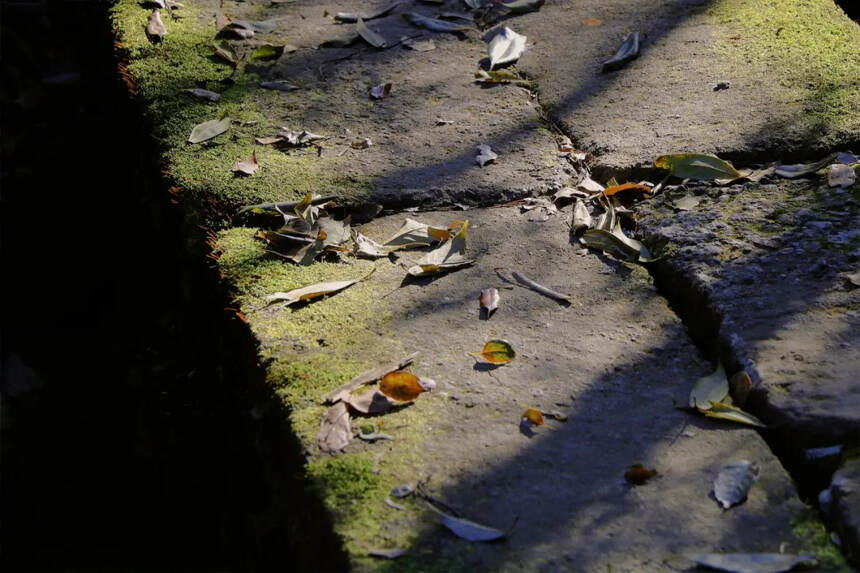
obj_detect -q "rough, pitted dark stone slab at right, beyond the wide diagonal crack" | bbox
[640,178,860,447]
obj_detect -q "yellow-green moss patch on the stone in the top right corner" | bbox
[709,0,860,134]
